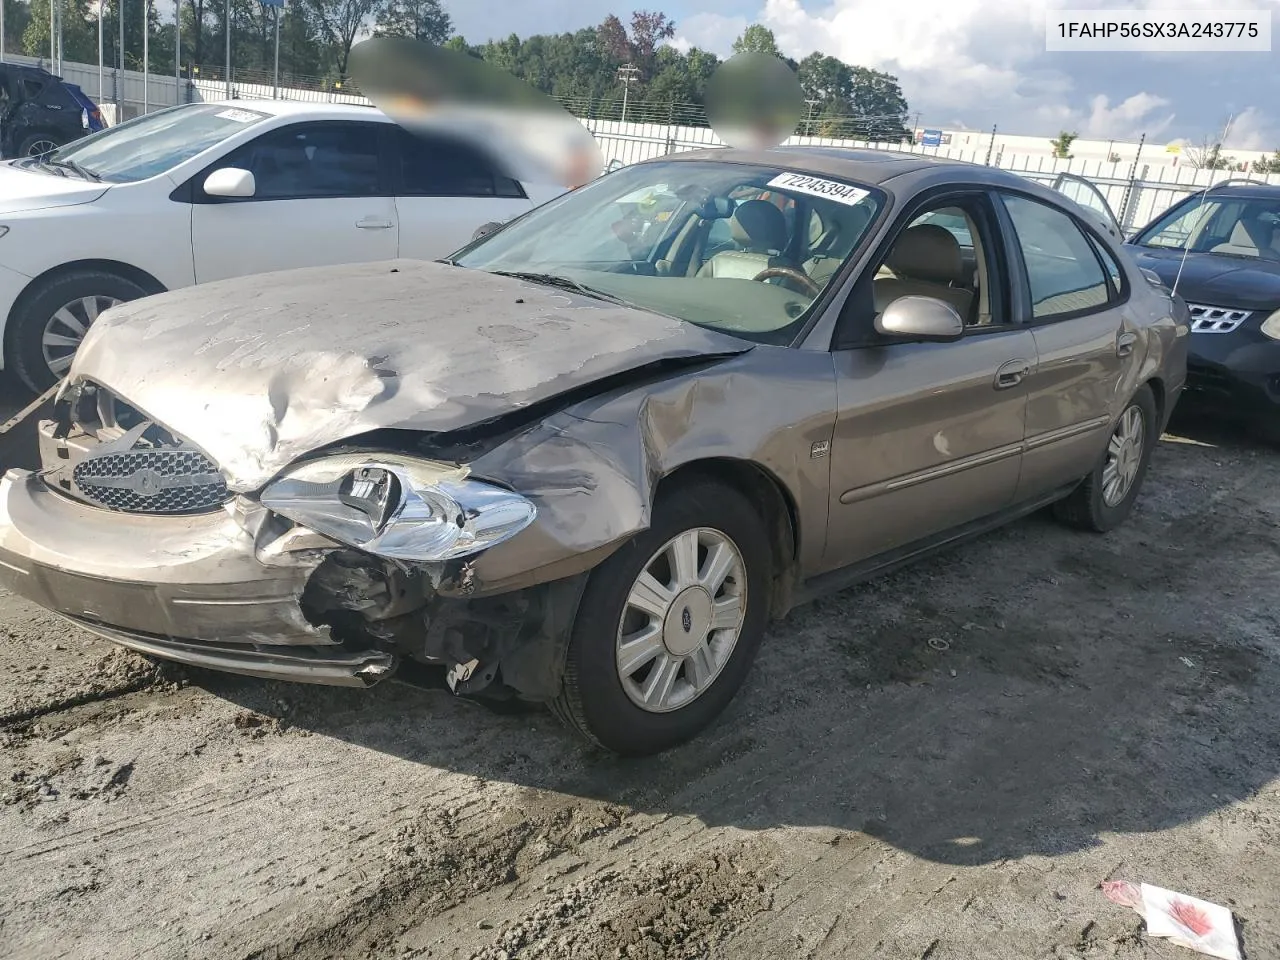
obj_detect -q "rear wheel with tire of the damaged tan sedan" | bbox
[1053,384,1160,534]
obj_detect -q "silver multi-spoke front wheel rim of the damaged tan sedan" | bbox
[616,527,746,713]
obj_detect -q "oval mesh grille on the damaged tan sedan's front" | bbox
[72,447,230,513]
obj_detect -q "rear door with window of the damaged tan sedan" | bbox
[1000,191,1140,499]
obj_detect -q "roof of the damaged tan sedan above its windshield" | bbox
[650,146,1028,189]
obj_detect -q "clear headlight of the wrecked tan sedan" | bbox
[261,453,538,562]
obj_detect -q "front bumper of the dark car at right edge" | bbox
[1183,330,1280,429]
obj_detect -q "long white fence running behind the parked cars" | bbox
[8,56,1280,229]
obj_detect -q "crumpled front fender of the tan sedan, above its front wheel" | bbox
[460,347,836,594]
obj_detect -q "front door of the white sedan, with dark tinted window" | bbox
[191,120,397,283]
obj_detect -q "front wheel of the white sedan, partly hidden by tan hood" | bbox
[6,270,147,393]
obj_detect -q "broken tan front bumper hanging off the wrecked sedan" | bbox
[0,470,396,686]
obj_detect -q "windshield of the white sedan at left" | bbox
[22,104,268,183]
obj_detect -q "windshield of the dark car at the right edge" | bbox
[1134,196,1280,260]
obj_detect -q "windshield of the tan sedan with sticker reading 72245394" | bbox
[454,160,883,344]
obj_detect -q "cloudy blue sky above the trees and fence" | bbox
[445,0,1280,152]
